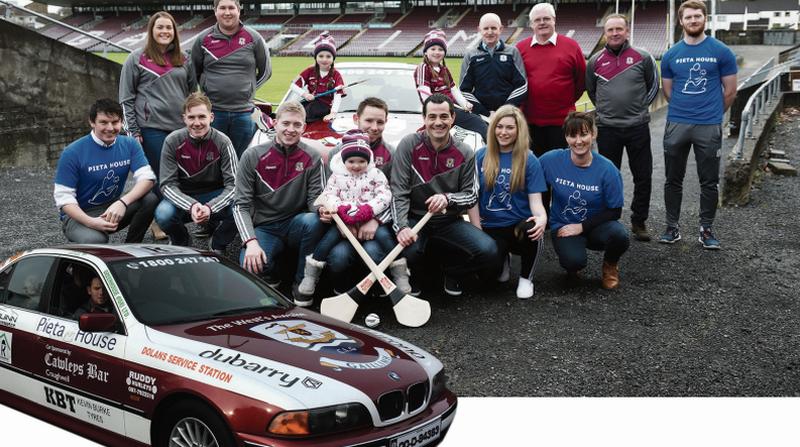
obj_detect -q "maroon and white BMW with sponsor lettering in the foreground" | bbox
[0,245,456,447]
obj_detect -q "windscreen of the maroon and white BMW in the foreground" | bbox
[108,254,290,326]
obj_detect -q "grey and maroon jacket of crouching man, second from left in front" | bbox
[160,128,237,213]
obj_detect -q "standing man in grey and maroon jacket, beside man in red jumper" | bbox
[586,14,658,242]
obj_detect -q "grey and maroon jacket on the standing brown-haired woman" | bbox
[119,49,197,136]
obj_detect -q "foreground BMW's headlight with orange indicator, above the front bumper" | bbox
[268,403,372,436]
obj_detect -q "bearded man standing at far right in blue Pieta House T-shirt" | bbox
[659,0,737,250]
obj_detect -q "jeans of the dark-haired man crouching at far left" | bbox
[61,191,158,244]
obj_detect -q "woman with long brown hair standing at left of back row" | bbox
[119,11,197,197]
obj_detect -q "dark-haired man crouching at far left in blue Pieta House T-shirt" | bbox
[53,99,158,244]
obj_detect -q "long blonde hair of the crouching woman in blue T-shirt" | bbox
[483,104,530,193]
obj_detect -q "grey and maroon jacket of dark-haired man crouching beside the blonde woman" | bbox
[390,130,478,232]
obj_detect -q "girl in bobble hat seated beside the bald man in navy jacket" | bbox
[414,29,488,140]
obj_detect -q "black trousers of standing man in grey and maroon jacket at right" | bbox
[597,123,653,226]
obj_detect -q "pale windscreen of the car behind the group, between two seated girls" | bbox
[337,67,422,113]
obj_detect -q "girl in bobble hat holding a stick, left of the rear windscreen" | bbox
[292,31,344,123]
